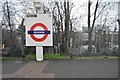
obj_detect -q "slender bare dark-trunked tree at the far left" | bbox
[3,2,16,49]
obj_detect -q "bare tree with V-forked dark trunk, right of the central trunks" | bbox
[88,0,117,53]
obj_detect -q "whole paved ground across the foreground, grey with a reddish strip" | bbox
[3,59,118,78]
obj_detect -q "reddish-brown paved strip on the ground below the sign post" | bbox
[3,61,54,78]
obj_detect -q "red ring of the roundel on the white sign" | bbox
[30,23,48,42]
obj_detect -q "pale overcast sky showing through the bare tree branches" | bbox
[0,0,120,30]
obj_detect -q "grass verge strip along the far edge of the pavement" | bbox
[2,53,118,60]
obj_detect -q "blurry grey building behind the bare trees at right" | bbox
[82,25,118,51]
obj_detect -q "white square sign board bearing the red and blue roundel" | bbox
[25,14,53,46]
